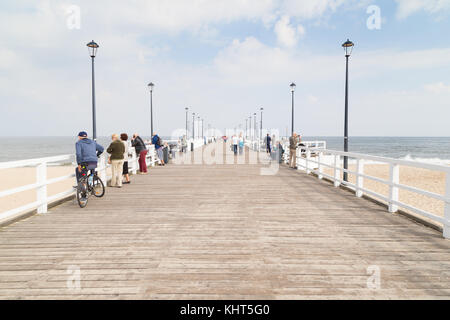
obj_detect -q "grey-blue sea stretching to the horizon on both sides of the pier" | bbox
[0,136,450,165]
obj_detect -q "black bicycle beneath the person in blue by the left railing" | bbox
[77,164,105,208]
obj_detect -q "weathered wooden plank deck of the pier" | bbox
[0,143,450,299]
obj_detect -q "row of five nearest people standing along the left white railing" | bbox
[75,131,165,188]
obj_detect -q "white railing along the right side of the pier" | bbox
[297,147,450,239]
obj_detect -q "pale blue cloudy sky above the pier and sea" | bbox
[0,0,450,136]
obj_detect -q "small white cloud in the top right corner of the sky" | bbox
[395,0,450,19]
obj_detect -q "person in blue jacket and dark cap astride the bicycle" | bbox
[75,131,104,182]
